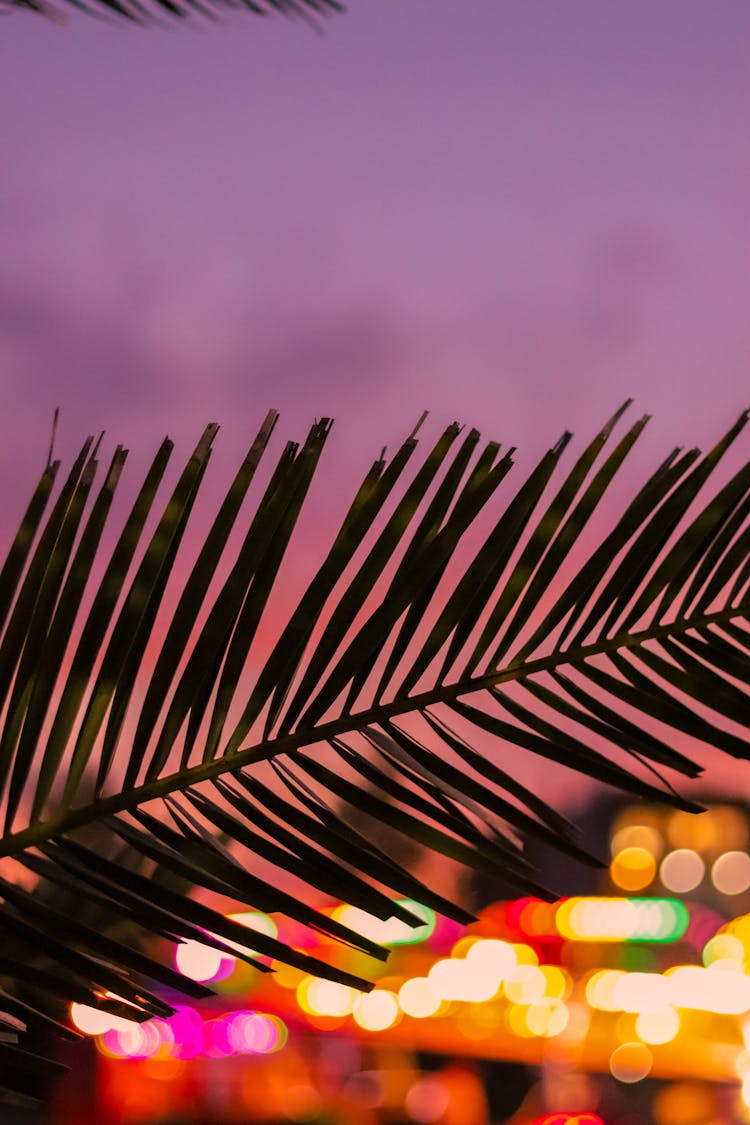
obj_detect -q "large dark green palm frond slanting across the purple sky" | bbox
[0,404,750,1090]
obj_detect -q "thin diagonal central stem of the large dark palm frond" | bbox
[0,600,750,857]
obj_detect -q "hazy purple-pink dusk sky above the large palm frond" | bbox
[0,0,750,810]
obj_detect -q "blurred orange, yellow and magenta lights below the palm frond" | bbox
[48,794,750,1125]
